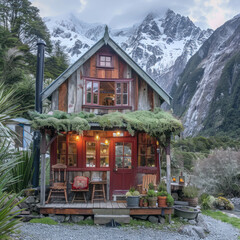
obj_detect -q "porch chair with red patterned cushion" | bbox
[71,176,89,203]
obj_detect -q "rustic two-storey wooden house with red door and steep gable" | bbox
[37,28,180,202]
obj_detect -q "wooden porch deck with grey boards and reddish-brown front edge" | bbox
[39,201,173,215]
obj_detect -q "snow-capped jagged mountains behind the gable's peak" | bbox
[45,10,213,92]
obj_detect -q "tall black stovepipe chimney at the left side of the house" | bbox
[32,39,46,187]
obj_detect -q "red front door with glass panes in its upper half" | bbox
[110,138,137,196]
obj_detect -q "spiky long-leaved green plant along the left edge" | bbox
[0,83,26,239]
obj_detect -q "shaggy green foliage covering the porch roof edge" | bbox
[30,109,183,138]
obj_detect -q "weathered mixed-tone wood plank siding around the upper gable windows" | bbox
[51,46,161,114]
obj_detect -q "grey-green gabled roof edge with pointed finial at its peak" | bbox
[41,26,172,104]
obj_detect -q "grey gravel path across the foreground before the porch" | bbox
[17,216,240,240]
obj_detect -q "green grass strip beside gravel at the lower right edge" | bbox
[202,210,240,229]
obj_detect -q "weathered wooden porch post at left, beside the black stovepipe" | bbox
[40,130,47,206]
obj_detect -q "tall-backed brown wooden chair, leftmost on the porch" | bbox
[46,163,68,203]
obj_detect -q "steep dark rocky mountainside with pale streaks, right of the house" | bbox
[172,15,240,137]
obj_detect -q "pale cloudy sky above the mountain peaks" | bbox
[31,0,240,29]
